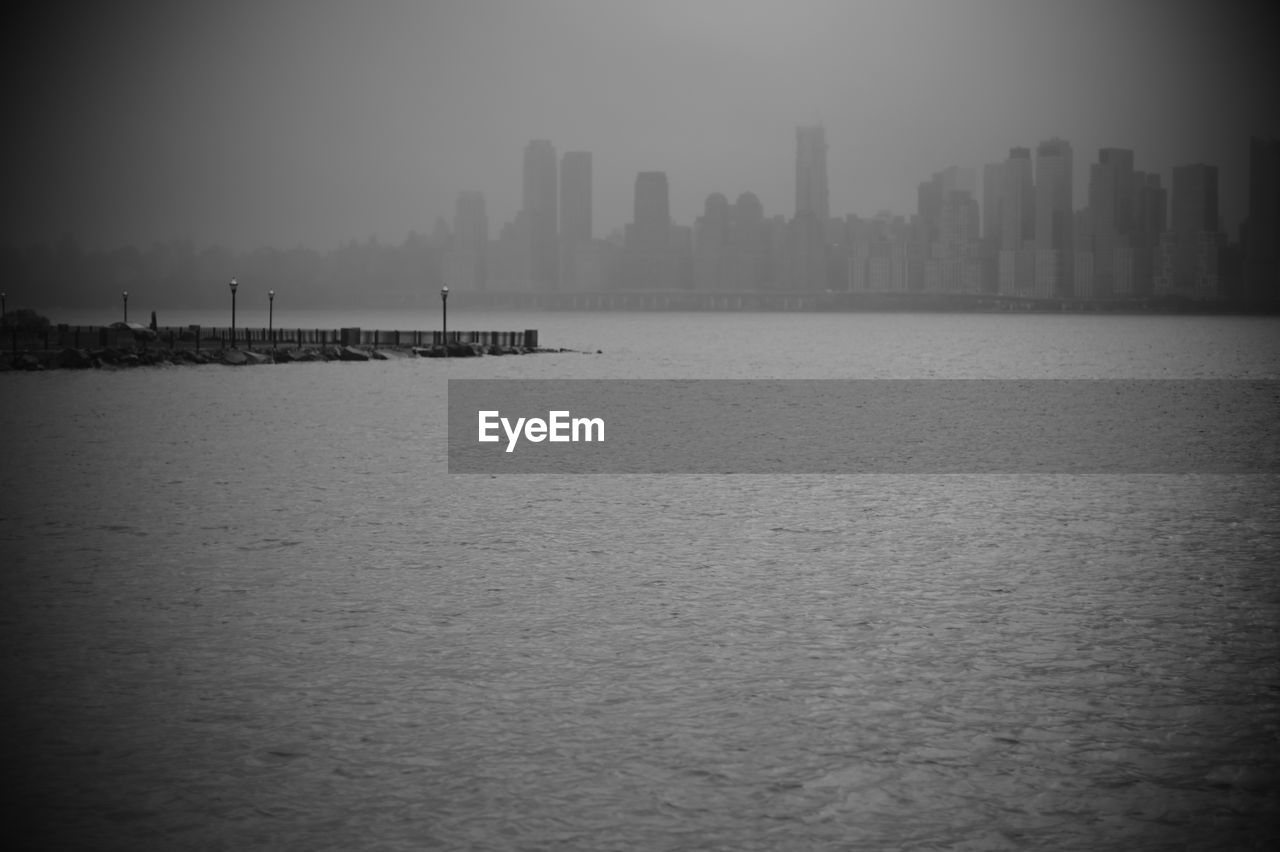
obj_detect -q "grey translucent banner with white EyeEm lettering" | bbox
[449,379,1280,473]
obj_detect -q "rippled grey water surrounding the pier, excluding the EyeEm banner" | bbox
[0,312,1280,852]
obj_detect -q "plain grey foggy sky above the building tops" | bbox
[0,0,1280,249]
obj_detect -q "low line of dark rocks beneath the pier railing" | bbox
[0,343,568,371]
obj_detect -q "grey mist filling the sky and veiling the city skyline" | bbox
[0,0,1276,308]
